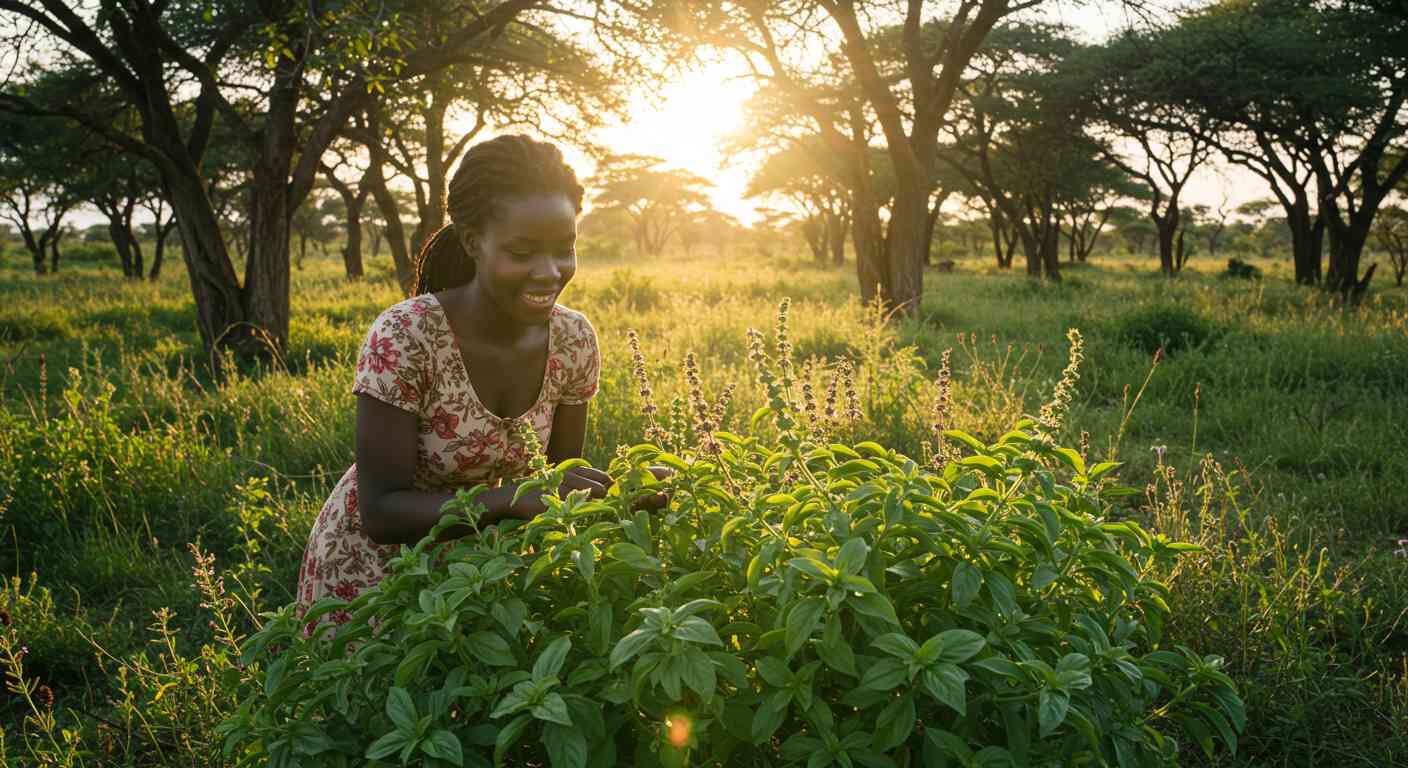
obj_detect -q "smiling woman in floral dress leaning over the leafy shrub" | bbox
[298,135,611,623]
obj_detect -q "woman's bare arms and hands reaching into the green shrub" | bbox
[356,395,610,544]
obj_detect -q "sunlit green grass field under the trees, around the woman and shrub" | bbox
[0,243,1408,768]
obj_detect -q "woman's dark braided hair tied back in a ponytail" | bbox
[411,134,583,296]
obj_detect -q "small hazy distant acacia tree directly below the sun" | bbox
[590,154,714,256]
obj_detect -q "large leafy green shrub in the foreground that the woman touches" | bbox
[221,311,1245,768]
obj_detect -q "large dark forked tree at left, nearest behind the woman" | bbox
[0,0,536,359]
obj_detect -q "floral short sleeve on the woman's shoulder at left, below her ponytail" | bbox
[352,303,427,416]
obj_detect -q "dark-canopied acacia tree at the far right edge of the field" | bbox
[1159,0,1408,297]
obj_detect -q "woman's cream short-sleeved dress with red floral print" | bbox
[298,295,601,624]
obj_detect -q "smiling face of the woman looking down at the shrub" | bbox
[465,194,577,326]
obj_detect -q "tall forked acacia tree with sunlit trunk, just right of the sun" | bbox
[677,0,1042,313]
